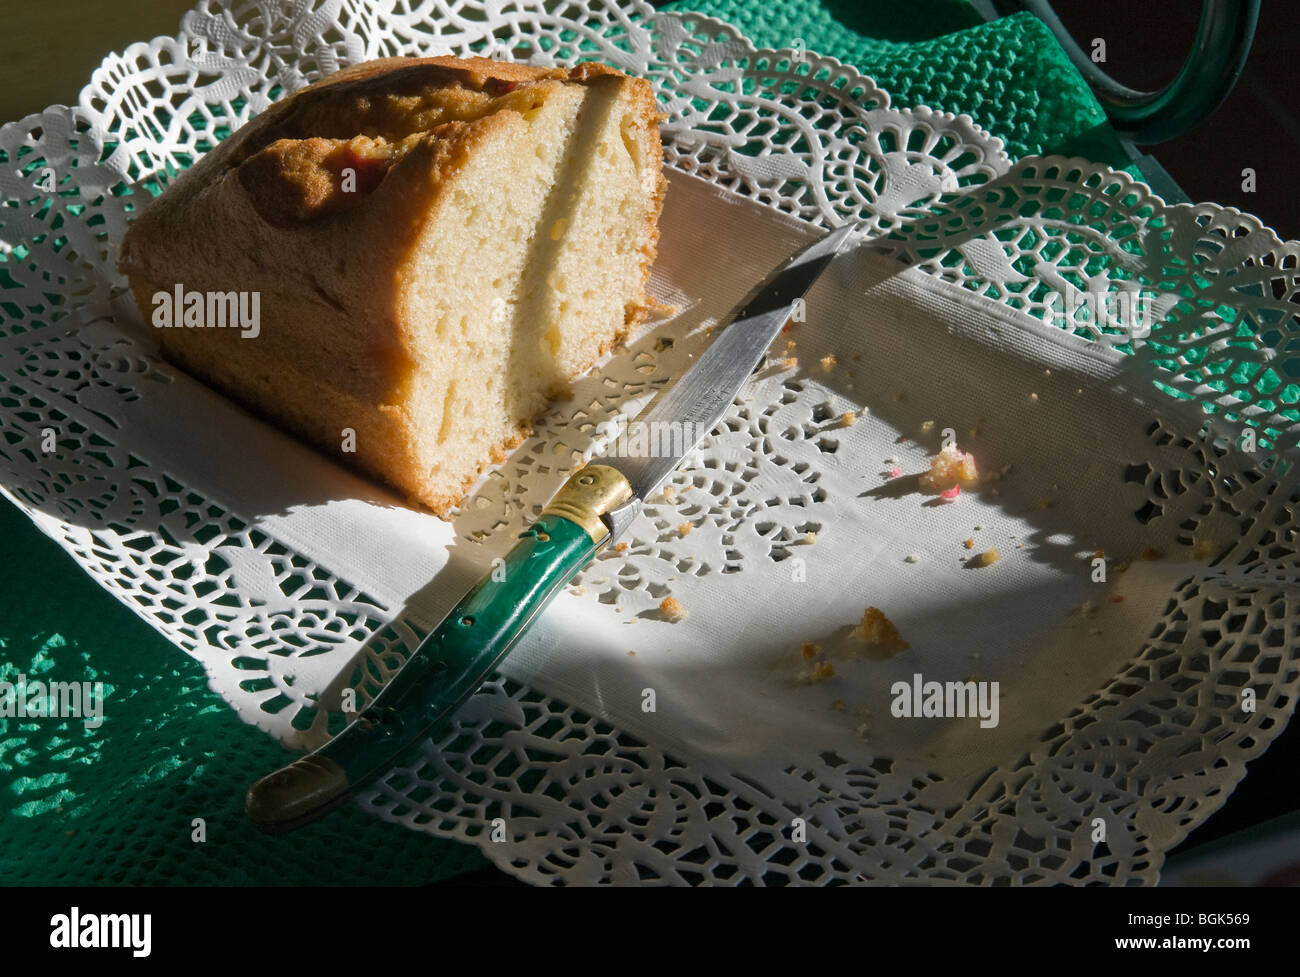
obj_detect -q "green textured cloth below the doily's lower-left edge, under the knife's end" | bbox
[0,503,486,885]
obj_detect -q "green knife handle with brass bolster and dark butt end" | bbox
[246,465,631,833]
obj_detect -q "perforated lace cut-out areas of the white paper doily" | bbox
[0,0,1300,882]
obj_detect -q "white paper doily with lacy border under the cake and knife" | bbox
[0,0,1300,883]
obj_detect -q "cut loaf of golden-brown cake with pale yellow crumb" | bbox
[121,57,666,514]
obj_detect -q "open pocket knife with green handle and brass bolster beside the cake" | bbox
[244,225,855,834]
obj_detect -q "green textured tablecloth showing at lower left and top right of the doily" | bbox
[0,0,1127,885]
